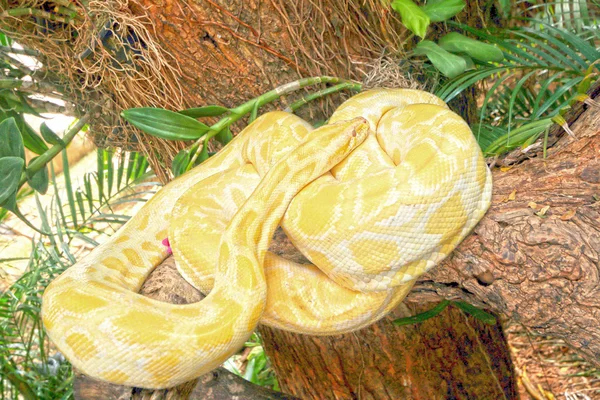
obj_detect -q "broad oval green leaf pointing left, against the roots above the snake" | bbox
[121,107,209,140]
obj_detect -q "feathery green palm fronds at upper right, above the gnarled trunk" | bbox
[436,20,600,155]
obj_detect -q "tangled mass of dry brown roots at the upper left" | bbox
[0,0,188,181]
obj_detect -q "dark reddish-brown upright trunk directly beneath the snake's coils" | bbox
[260,303,517,399]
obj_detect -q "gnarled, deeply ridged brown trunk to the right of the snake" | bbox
[409,85,600,364]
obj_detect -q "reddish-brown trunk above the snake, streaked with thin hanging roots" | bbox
[127,0,406,118]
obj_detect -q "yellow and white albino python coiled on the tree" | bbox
[42,89,491,388]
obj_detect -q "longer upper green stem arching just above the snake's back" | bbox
[186,76,360,170]
